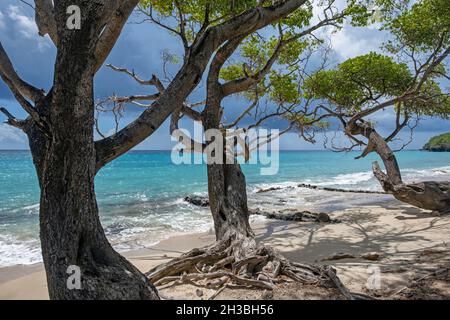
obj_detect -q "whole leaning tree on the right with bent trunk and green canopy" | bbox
[300,0,450,212]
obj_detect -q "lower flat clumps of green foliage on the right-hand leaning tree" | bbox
[304,52,450,118]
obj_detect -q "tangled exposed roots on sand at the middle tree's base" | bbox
[146,239,367,299]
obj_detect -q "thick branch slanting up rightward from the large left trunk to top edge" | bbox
[96,0,306,170]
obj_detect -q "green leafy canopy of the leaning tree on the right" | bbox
[288,0,450,149]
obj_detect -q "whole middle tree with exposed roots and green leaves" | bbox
[131,1,372,298]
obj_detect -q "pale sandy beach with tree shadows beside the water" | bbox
[0,200,450,299]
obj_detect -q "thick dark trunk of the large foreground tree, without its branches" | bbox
[18,1,159,299]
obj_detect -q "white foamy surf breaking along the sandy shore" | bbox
[0,166,450,266]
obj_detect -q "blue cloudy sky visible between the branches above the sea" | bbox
[0,0,450,150]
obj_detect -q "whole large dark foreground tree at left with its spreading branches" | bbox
[0,0,312,299]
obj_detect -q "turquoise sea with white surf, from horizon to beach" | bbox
[0,151,450,266]
